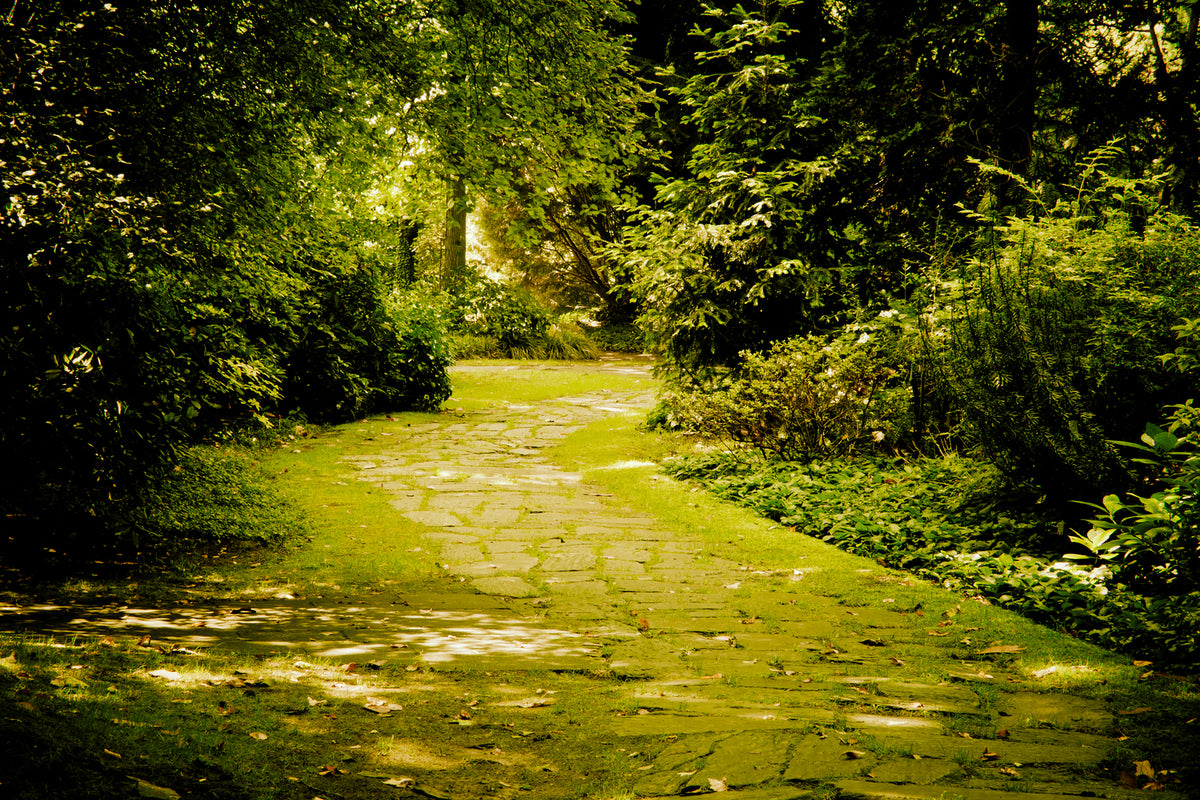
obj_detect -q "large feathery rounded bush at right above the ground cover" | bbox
[948,149,1200,498]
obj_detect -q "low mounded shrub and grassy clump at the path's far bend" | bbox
[448,275,600,360]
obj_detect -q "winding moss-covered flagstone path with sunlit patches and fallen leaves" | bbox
[4,362,1176,800]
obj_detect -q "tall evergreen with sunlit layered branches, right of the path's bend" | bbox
[616,2,835,379]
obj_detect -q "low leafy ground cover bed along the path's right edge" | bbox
[667,453,1200,666]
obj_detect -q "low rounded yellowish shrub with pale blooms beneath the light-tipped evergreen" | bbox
[677,323,908,459]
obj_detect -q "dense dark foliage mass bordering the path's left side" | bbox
[0,0,445,537]
